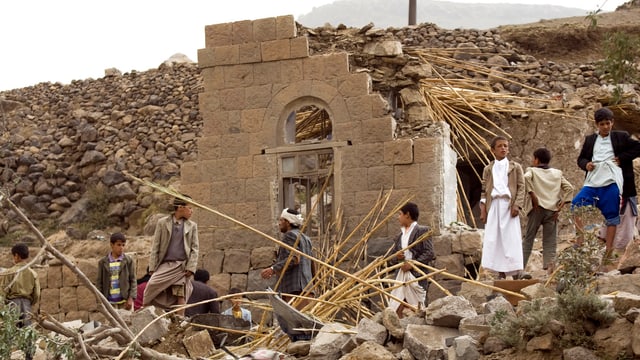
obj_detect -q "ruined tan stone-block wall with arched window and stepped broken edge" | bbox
[181,16,456,293]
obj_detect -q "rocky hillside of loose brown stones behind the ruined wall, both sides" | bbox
[0,0,640,242]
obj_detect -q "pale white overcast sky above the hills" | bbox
[0,0,626,91]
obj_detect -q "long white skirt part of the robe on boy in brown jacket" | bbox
[481,197,523,276]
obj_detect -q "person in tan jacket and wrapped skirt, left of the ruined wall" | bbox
[144,198,199,316]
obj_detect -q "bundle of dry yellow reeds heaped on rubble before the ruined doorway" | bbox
[129,175,522,358]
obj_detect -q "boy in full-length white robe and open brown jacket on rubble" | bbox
[480,136,524,279]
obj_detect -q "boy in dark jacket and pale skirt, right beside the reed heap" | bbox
[389,202,436,317]
